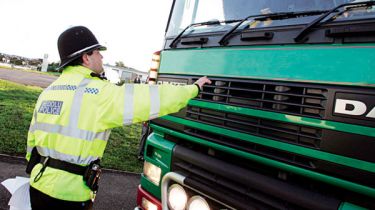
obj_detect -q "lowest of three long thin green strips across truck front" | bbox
[151,124,375,198]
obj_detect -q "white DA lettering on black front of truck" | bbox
[334,99,375,118]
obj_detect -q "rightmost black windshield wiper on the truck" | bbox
[294,1,375,42]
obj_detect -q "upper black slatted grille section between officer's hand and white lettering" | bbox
[193,79,328,119]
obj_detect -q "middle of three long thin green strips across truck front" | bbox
[162,116,375,173]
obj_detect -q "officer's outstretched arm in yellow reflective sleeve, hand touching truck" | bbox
[97,77,211,129]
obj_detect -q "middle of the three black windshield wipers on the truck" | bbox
[219,10,327,45]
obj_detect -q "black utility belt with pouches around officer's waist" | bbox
[26,147,102,192]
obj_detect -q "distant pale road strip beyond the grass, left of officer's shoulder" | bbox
[0,68,57,88]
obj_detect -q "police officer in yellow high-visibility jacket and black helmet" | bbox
[26,26,211,210]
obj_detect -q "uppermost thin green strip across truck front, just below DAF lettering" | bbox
[189,100,375,137]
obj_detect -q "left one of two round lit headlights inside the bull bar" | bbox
[168,184,187,210]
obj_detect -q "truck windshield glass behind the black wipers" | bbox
[166,0,375,37]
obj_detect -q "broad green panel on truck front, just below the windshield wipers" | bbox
[159,43,375,87]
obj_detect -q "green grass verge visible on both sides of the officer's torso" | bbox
[0,80,142,173]
